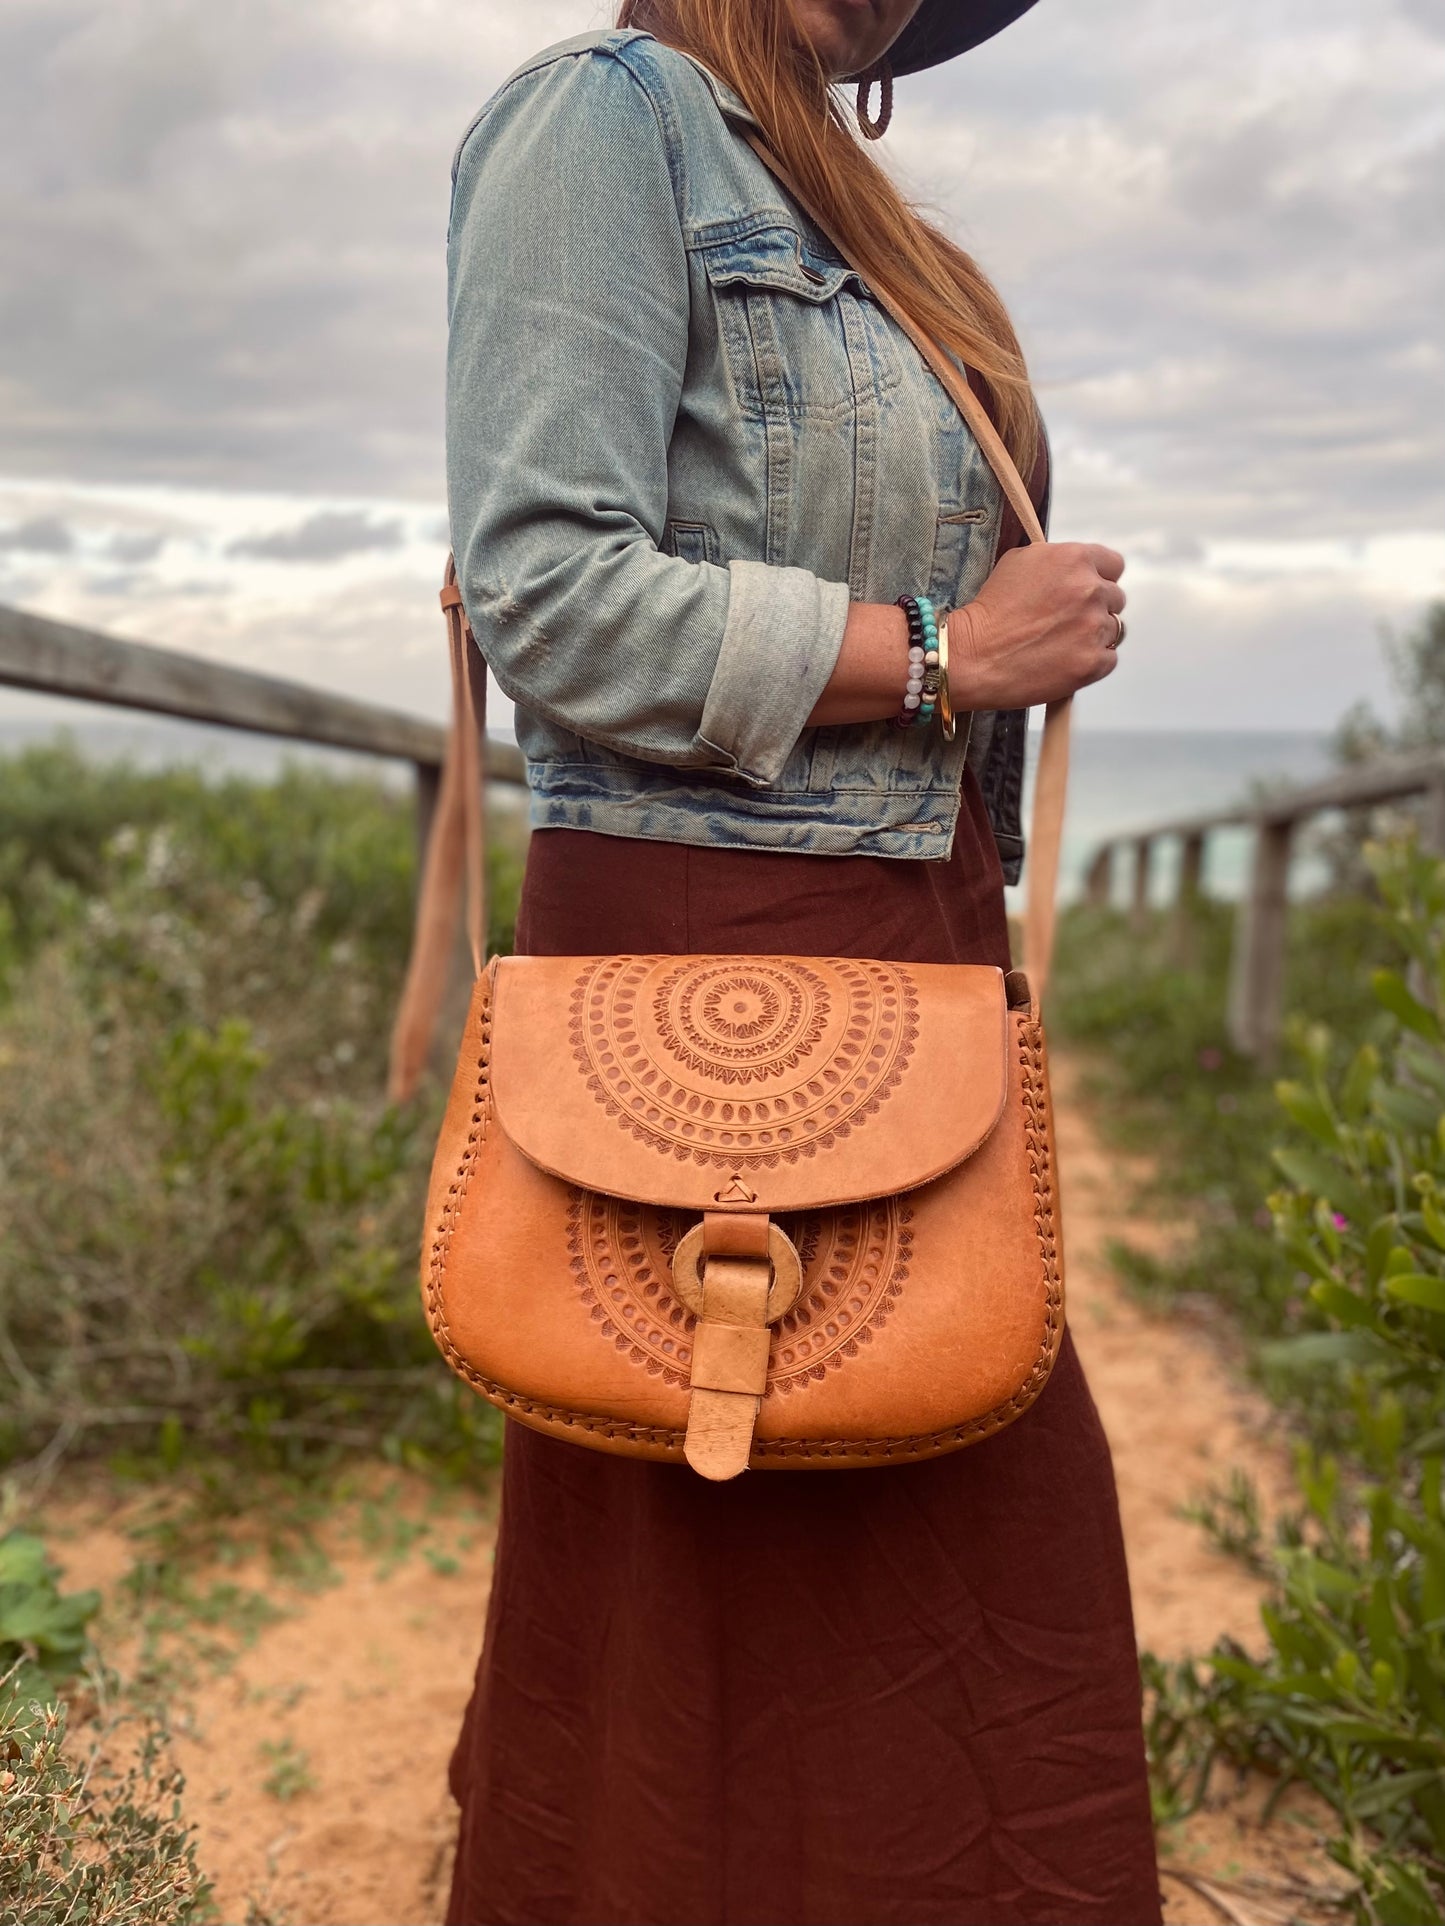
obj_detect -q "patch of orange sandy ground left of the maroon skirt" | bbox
[44,1471,495,1926]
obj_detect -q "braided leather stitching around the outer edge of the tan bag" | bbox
[426,994,1064,1464]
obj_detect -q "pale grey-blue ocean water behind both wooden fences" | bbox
[0,703,1329,899]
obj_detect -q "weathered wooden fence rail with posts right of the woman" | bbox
[1085,755,1445,1063]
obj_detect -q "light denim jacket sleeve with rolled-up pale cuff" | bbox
[447,50,848,786]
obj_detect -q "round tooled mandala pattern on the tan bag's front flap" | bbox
[570,957,917,1169]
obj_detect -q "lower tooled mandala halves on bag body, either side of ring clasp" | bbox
[566,1190,913,1392]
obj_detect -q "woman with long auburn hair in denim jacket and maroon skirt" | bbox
[449,0,1160,1926]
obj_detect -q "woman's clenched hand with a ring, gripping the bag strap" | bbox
[948,541,1125,711]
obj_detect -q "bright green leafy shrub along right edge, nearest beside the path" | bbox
[1148,844,1445,1926]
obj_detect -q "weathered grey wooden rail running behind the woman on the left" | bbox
[0,605,526,847]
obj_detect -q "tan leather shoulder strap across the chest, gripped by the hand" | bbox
[744,135,1073,998]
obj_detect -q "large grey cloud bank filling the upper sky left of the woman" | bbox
[0,0,597,501]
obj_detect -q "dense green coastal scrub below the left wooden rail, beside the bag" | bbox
[0,749,520,1470]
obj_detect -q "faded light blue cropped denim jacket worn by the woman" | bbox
[447,31,1023,872]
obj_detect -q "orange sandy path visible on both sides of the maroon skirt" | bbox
[36,1065,1356,1926]
